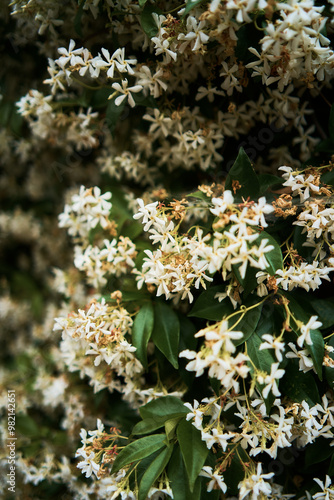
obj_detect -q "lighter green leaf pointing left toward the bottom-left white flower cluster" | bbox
[112,434,166,474]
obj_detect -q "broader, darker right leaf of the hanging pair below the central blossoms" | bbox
[152,302,180,368]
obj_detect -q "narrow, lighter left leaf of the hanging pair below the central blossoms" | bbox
[132,302,154,369]
